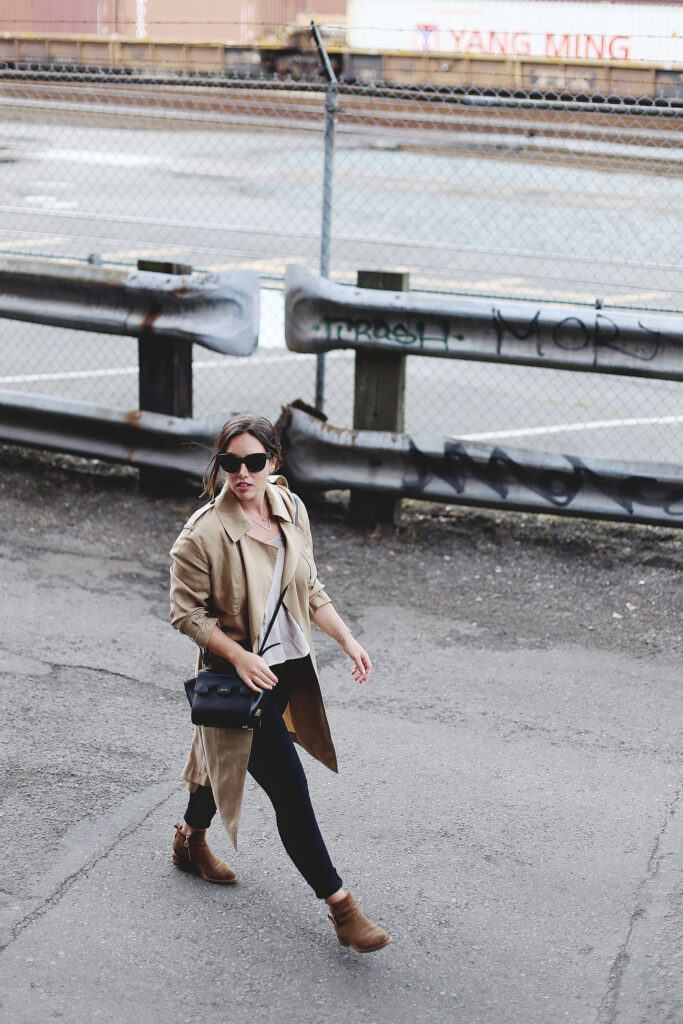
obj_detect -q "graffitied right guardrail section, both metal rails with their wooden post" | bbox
[285,266,683,525]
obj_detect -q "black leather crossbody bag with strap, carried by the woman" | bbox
[184,584,289,729]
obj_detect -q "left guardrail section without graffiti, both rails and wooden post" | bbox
[0,257,259,493]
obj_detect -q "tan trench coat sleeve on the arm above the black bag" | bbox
[171,529,218,647]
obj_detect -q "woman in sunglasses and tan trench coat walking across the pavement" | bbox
[171,416,391,952]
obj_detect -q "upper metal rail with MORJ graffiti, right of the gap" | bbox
[286,266,683,381]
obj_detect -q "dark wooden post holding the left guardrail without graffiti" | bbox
[137,260,193,495]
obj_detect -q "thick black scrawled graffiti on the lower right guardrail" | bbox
[402,439,683,520]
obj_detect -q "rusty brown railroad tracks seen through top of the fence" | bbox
[0,72,683,155]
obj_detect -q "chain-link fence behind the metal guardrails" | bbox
[0,65,683,464]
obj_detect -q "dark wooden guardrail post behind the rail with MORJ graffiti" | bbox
[349,270,411,525]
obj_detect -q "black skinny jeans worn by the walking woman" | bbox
[185,659,342,899]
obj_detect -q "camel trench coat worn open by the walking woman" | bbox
[171,476,338,848]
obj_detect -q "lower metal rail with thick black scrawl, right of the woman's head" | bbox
[282,407,683,526]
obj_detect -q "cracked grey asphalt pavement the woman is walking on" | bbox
[0,447,683,1024]
